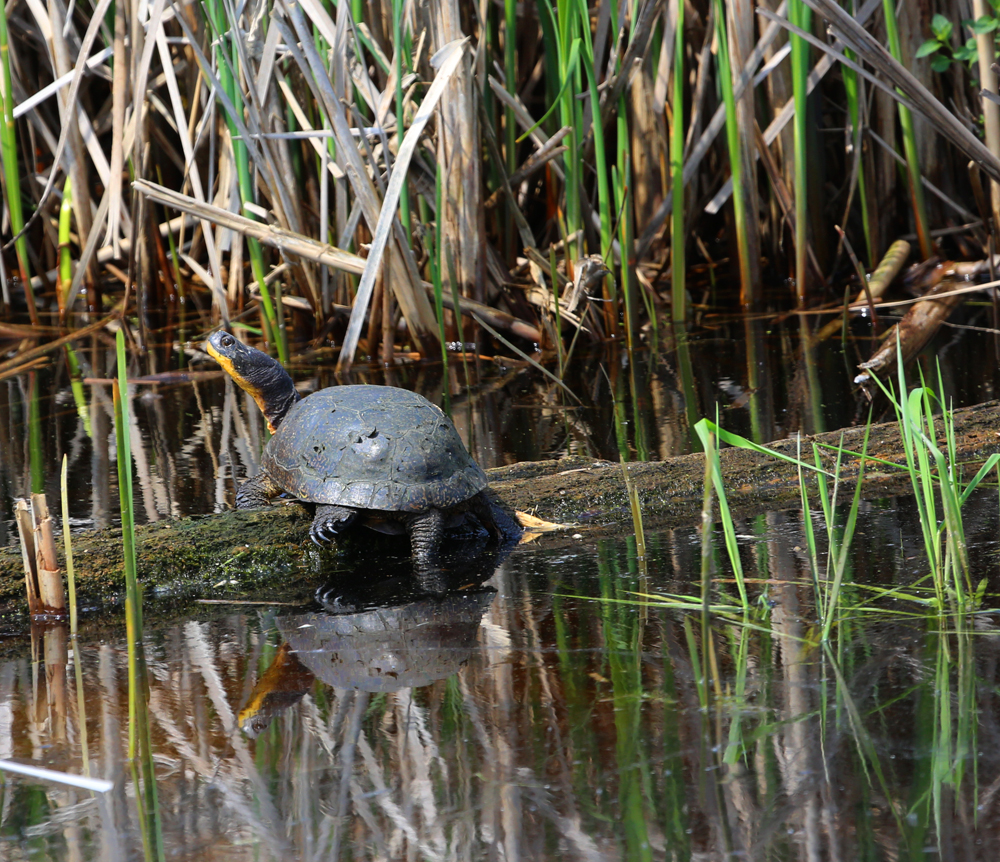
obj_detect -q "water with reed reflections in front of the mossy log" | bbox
[0,500,1000,860]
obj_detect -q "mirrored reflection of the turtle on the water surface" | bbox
[239,586,496,737]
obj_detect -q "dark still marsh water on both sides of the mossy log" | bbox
[0,321,1000,860]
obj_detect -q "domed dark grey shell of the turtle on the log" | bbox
[261,386,487,512]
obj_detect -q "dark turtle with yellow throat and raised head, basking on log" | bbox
[206,330,521,568]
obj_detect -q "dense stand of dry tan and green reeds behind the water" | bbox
[0,0,1000,375]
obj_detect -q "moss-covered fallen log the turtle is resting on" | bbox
[0,402,1000,633]
